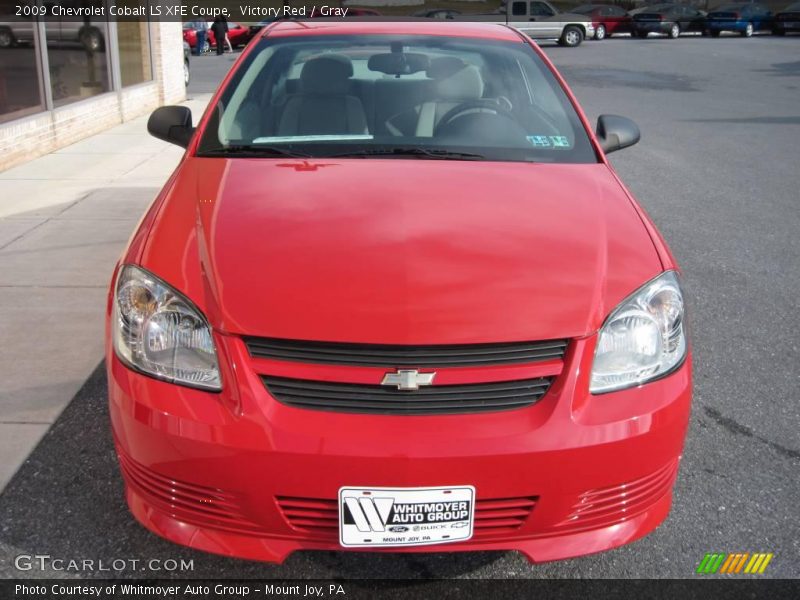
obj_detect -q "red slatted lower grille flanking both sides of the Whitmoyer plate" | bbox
[276,496,538,541]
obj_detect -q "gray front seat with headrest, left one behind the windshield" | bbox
[277,54,368,136]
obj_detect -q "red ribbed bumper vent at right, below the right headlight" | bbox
[553,461,678,533]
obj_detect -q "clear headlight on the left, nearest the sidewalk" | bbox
[113,265,222,390]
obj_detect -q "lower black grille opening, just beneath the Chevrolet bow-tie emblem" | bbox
[261,375,552,415]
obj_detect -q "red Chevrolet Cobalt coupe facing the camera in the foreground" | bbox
[107,20,692,562]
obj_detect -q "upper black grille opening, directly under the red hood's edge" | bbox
[245,337,567,368]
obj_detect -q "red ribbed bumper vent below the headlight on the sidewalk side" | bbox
[118,452,264,535]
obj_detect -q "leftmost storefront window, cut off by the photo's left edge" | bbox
[0,17,44,123]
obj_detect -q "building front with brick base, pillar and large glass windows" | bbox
[0,18,186,171]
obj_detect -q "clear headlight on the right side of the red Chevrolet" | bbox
[589,271,687,394]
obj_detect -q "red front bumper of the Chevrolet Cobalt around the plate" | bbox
[107,335,691,562]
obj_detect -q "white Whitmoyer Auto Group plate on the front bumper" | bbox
[339,485,475,548]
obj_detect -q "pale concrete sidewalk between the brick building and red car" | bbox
[0,94,210,490]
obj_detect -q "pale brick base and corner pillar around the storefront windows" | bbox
[0,23,186,171]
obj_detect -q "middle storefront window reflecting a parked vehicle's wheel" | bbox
[45,19,111,107]
